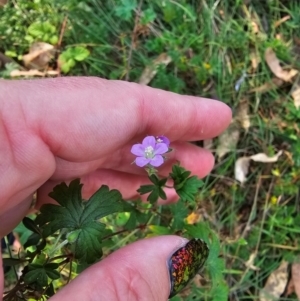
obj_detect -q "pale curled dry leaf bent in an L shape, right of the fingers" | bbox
[234,150,283,184]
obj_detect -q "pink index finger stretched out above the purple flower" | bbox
[5,77,231,161]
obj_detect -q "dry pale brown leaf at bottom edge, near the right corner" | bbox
[259,261,289,301]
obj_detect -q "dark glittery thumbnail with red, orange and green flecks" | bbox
[168,239,209,298]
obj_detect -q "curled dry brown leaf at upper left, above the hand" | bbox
[23,42,54,69]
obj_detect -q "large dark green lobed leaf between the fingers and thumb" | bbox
[36,179,125,263]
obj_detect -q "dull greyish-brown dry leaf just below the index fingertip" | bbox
[216,121,240,159]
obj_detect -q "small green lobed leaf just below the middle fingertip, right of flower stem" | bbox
[170,165,203,202]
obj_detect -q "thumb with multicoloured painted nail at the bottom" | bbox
[50,236,208,301]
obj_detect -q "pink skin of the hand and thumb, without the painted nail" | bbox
[0,77,231,301]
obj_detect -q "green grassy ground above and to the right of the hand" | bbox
[0,0,300,301]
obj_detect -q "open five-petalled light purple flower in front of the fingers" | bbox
[131,136,169,167]
